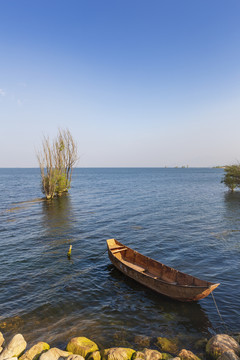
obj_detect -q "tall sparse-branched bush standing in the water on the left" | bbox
[37,129,78,199]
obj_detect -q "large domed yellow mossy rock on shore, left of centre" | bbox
[66,337,99,358]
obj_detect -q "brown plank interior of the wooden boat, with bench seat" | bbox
[108,239,211,287]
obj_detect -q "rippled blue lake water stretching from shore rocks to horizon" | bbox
[0,168,240,349]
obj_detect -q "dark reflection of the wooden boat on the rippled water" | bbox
[107,265,213,336]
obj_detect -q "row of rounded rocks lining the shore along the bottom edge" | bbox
[0,332,240,360]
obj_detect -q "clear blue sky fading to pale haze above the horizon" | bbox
[0,0,240,167]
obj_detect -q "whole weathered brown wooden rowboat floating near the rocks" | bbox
[107,239,220,301]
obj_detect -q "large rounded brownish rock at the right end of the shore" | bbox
[206,334,240,359]
